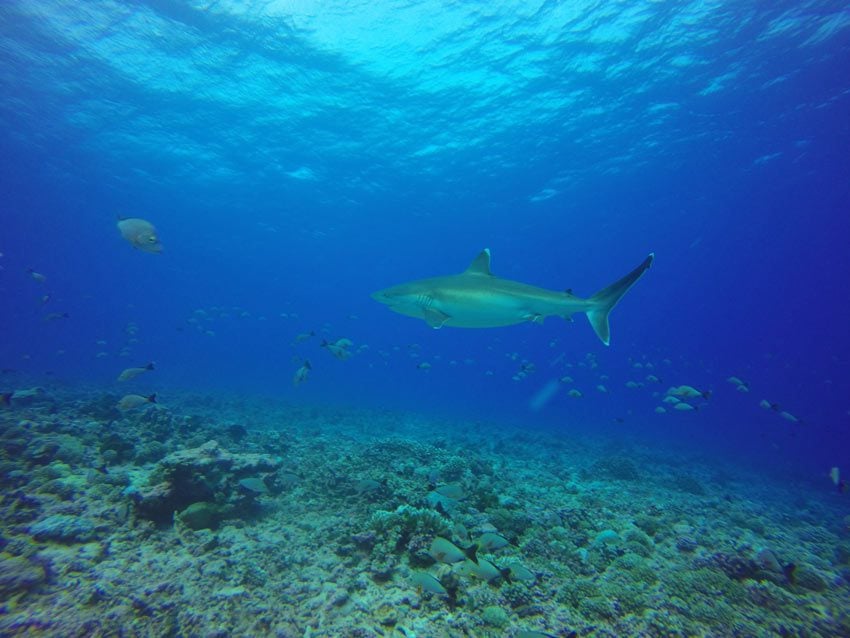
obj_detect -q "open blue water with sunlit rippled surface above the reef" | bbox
[0,0,850,478]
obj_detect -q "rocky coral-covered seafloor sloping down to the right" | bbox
[0,388,850,637]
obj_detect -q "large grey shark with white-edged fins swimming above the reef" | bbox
[372,248,655,346]
